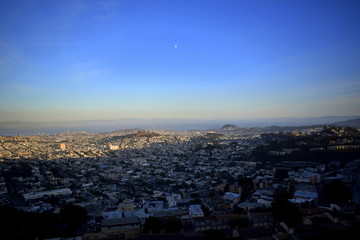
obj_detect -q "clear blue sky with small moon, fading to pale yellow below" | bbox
[0,0,360,121]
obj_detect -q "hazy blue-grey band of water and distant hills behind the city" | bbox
[0,116,360,136]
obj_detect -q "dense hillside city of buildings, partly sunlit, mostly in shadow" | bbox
[0,124,360,240]
